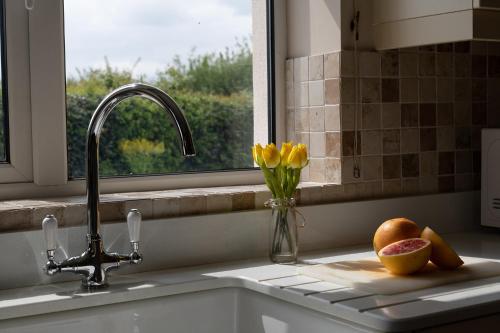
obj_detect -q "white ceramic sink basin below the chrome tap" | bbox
[0,288,359,333]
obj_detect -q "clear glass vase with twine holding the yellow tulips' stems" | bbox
[266,198,299,264]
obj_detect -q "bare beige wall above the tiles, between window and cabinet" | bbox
[287,0,373,58]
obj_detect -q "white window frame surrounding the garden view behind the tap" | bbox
[0,0,286,199]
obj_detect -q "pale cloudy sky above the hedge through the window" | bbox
[64,0,252,77]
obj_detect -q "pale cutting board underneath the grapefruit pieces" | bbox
[299,257,500,295]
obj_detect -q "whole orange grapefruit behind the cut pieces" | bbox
[373,217,420,254]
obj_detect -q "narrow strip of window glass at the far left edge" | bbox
[0,1,9,163]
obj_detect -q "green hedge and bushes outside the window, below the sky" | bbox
[66,44,253,177]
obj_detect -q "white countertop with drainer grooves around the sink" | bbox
[0,231,500,331]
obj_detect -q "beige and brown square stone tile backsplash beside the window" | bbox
[286,41,500,197]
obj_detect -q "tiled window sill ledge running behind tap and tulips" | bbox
[0,181,450,233]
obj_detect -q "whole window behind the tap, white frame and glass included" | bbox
[0,0,285,198]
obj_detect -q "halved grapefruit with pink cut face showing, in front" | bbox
[378,238,432,275]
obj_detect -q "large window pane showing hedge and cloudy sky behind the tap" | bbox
[64,0,253,178]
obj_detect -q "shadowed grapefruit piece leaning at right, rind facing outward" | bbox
[420,227,464,269]
